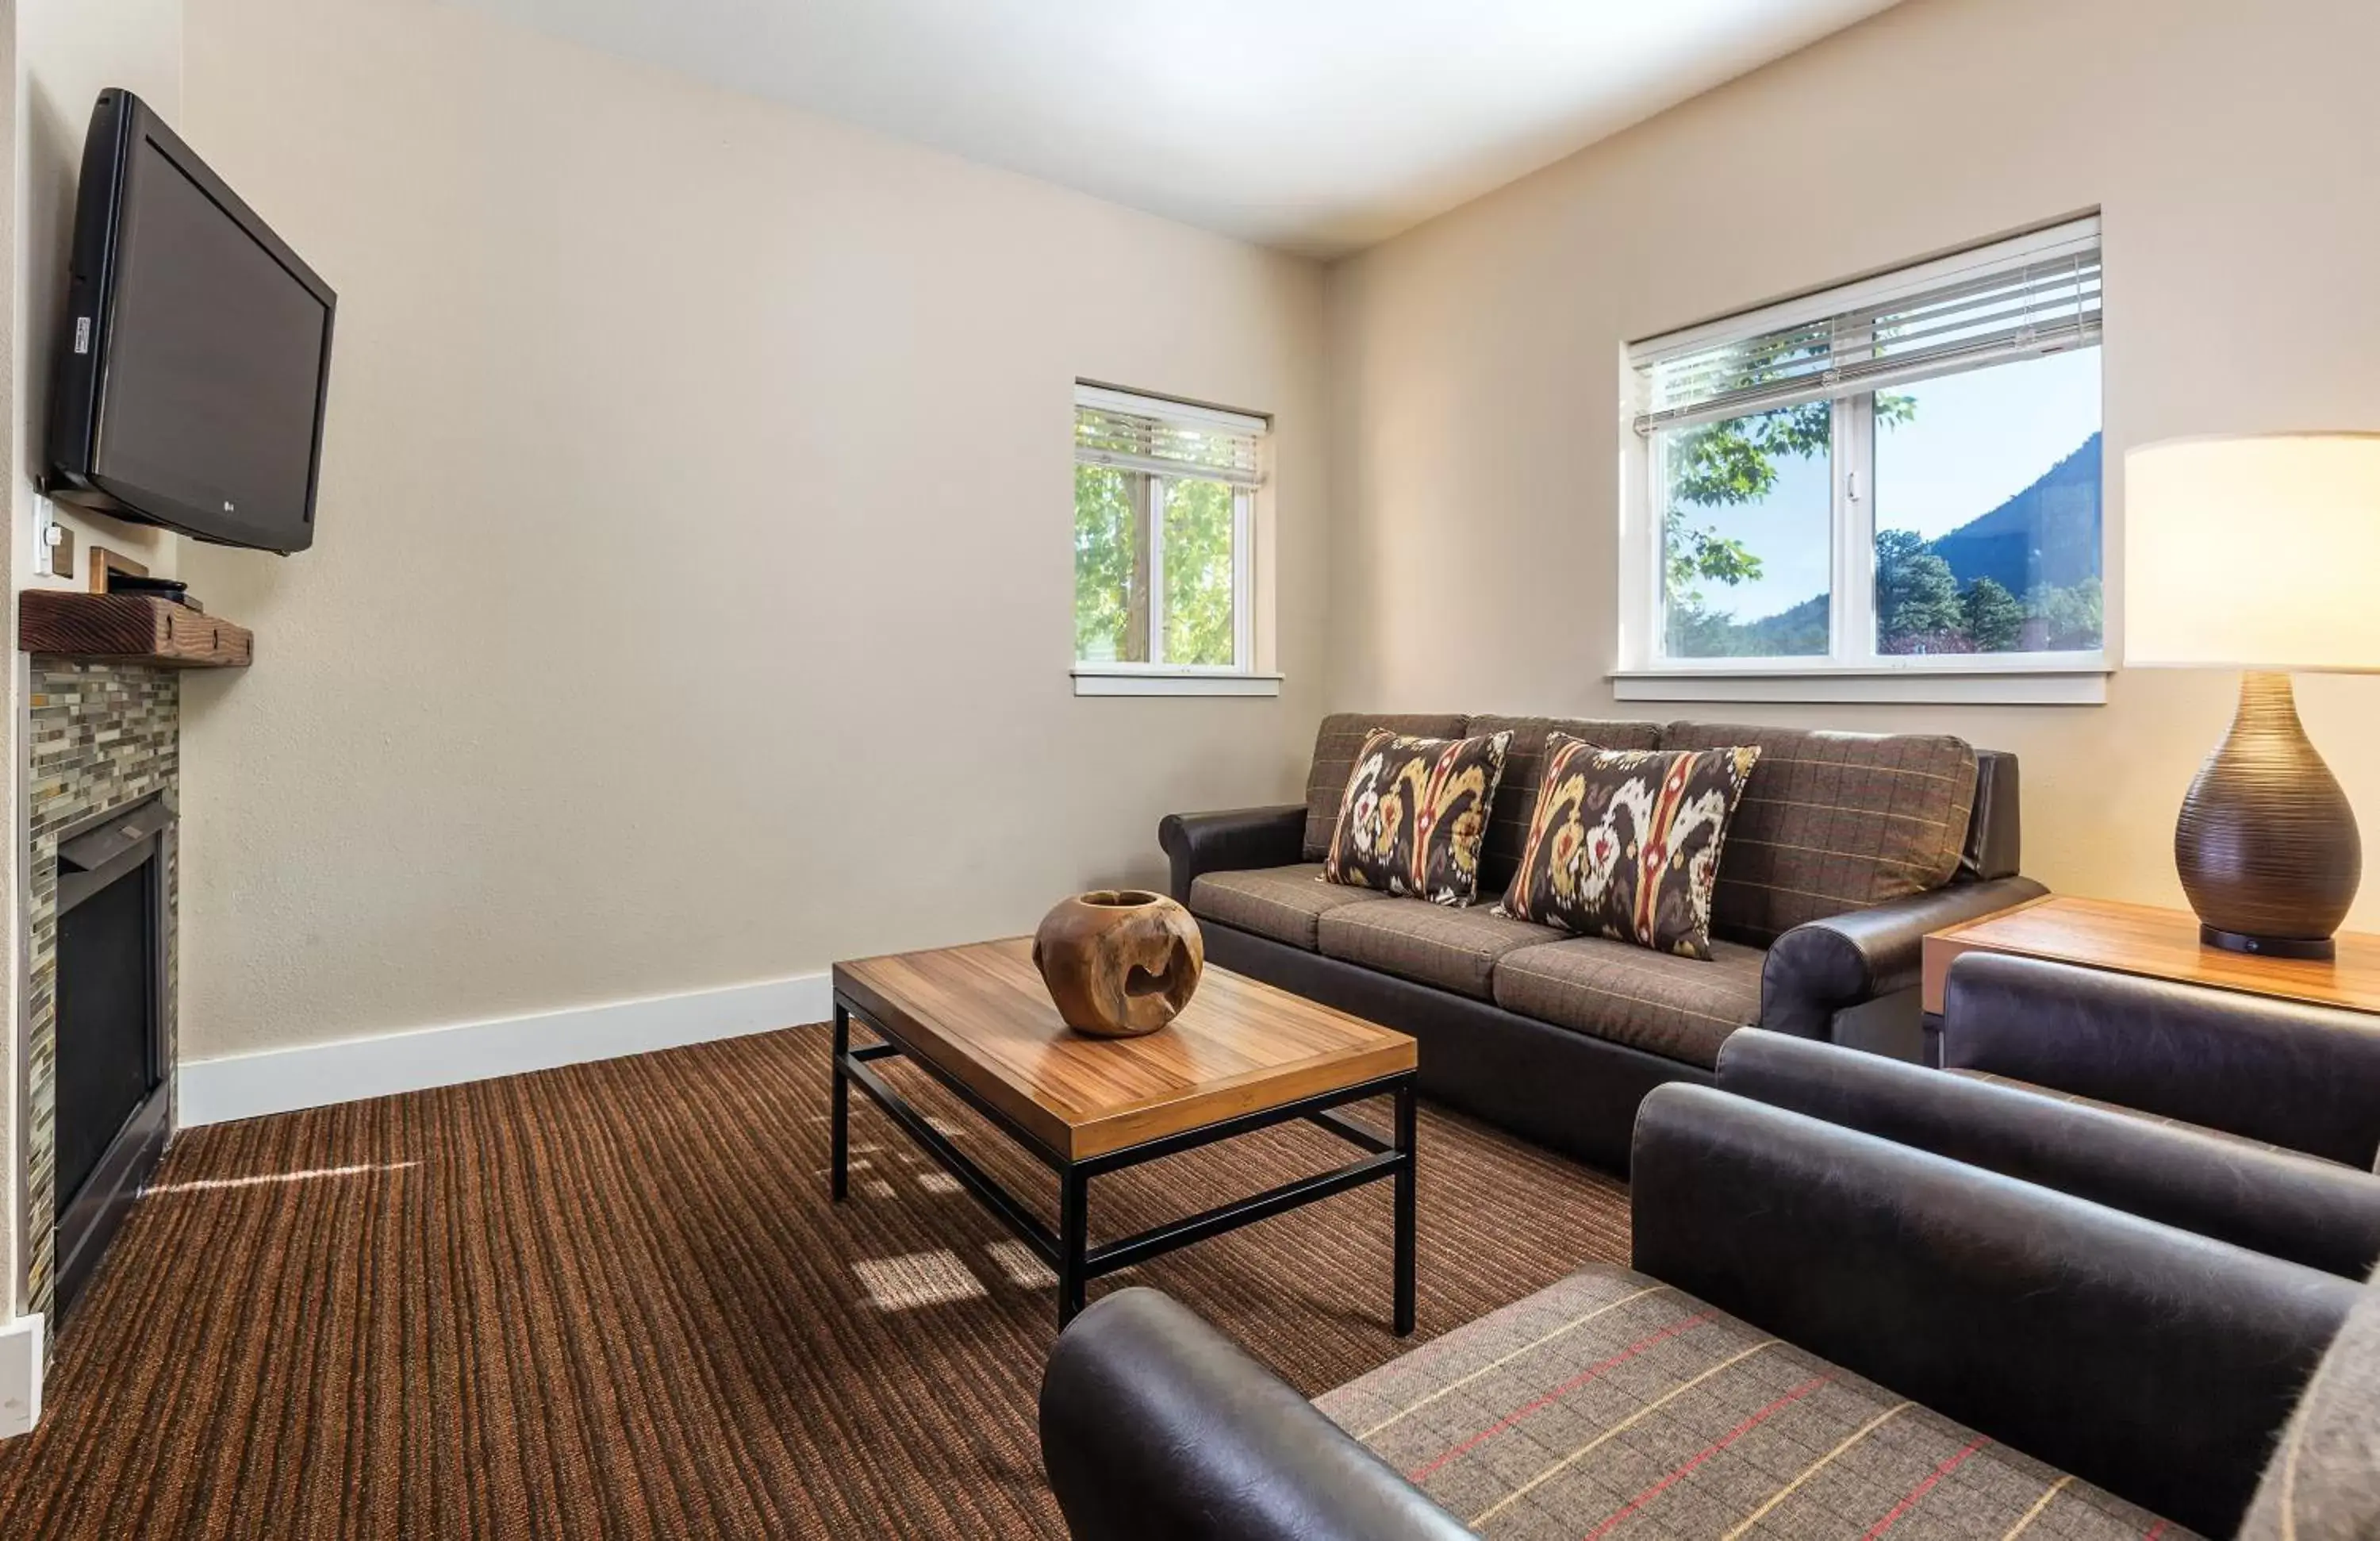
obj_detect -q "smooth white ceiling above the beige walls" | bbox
[462,0,1892,255]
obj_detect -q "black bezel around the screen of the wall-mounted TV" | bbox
[43,88,338,555]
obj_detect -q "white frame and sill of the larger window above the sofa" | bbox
[1609,217,2118,705]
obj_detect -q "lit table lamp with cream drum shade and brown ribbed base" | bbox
[2123,433,2380,958]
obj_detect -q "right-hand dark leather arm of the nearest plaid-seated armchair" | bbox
[1630,1086,2361,1536]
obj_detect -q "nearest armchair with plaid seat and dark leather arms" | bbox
[1042,1081,2366,1541]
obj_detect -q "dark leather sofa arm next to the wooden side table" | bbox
[1761,877,2047,1039]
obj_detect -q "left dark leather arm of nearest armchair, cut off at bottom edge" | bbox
[1040,1289,1471,1541]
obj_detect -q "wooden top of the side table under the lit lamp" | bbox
[1921,893,2380,1015]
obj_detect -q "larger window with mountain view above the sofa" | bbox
[1621,219,2102,700]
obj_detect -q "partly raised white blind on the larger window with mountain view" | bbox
[1628,217,2099,433]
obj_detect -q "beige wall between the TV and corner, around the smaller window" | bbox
[181,0,1328,1058]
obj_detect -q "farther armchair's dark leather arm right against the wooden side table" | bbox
[1942,953,2380,1172]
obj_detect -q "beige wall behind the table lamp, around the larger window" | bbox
[1330,0,2380,927]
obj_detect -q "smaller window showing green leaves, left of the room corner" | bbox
[1073,386,1269,676]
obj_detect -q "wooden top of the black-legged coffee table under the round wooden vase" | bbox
[835,936,1418,1160]
